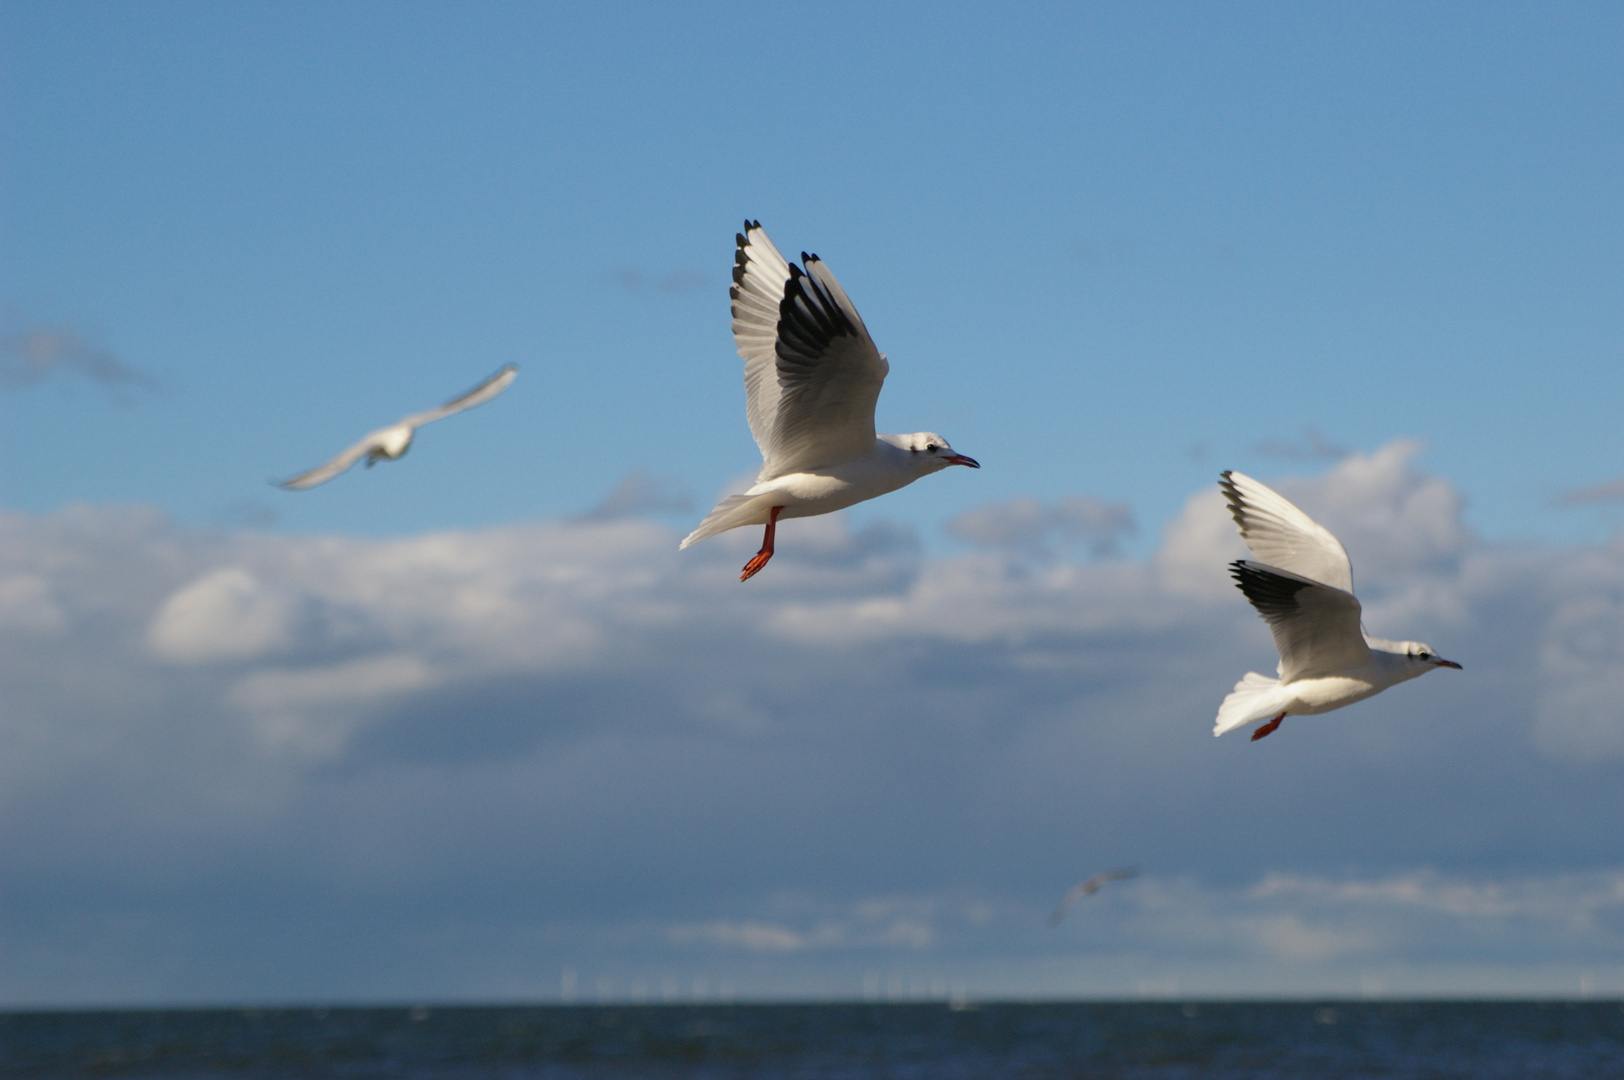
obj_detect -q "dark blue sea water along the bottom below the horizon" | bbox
[0,1002,1624,1080]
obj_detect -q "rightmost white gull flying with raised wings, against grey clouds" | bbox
[1213,473,1460,742]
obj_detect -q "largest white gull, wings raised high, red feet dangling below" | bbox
[682,221,981,581]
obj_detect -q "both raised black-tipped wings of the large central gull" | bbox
[731,222,890,481]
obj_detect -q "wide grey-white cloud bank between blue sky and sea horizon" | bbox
[0,443,1624,1004]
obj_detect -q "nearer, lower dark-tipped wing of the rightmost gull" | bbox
[1229,559,1371,682]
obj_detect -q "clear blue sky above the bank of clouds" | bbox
[0,3,1624,542]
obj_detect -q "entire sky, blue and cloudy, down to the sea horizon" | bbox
[0,3,1624,1002]
